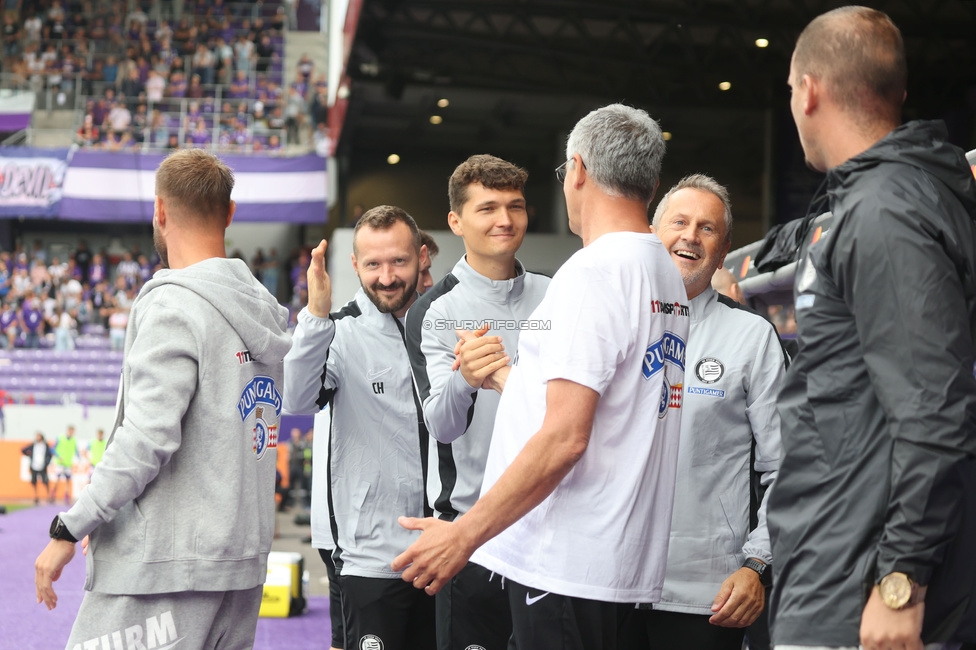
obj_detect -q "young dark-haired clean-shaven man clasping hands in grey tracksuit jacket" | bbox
[407,155,549,650]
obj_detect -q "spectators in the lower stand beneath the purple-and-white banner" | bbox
[0,240,309,350]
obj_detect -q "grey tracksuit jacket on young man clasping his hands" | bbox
[407,257,549,521]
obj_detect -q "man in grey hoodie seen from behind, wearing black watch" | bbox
[35,149,290,648]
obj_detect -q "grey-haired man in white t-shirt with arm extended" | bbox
[394,104,689,650]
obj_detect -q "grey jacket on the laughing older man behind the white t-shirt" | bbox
[654,287,786,615]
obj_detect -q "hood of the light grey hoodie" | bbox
[139,257,291,361]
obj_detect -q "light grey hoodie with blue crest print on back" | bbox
[62,258,291,594]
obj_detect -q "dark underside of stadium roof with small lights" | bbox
[340,0,976,160]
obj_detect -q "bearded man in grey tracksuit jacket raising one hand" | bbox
[284,206,434,650]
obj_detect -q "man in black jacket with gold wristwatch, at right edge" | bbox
[768,7,976,650]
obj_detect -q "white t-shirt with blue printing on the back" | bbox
[472,233,690,603]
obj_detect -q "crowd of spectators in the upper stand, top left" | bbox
[2,0,327,152]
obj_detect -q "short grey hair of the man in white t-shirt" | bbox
[566,104,665,205]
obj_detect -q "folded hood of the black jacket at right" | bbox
[828,121,976,220]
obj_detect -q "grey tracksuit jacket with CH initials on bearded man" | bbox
[285,289,427,578]
